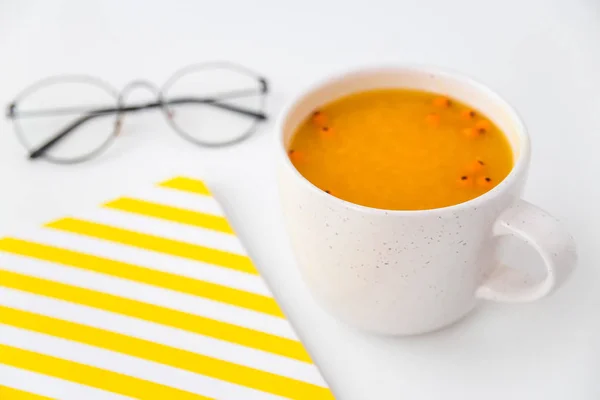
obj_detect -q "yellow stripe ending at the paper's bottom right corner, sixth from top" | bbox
[0,306,333,400]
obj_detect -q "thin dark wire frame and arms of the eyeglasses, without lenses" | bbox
[6,62,269,164]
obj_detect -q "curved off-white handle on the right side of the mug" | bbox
[476,200,577,303]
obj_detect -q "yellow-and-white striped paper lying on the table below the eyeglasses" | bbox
[0,177,334,400]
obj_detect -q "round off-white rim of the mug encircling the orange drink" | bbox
[275,64,531,216]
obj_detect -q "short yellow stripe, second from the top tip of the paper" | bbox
[104,197,233,234]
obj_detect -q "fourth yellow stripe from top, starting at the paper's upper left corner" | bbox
[0,238,283,318]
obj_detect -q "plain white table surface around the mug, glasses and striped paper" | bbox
[0,0,600,400]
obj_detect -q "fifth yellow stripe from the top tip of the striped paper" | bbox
[0,269,311,363]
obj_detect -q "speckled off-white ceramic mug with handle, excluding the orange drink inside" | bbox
[276,66,577,334]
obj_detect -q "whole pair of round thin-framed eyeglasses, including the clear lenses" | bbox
[7,62,269,163]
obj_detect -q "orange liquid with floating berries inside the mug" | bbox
[288,89,513,210]
